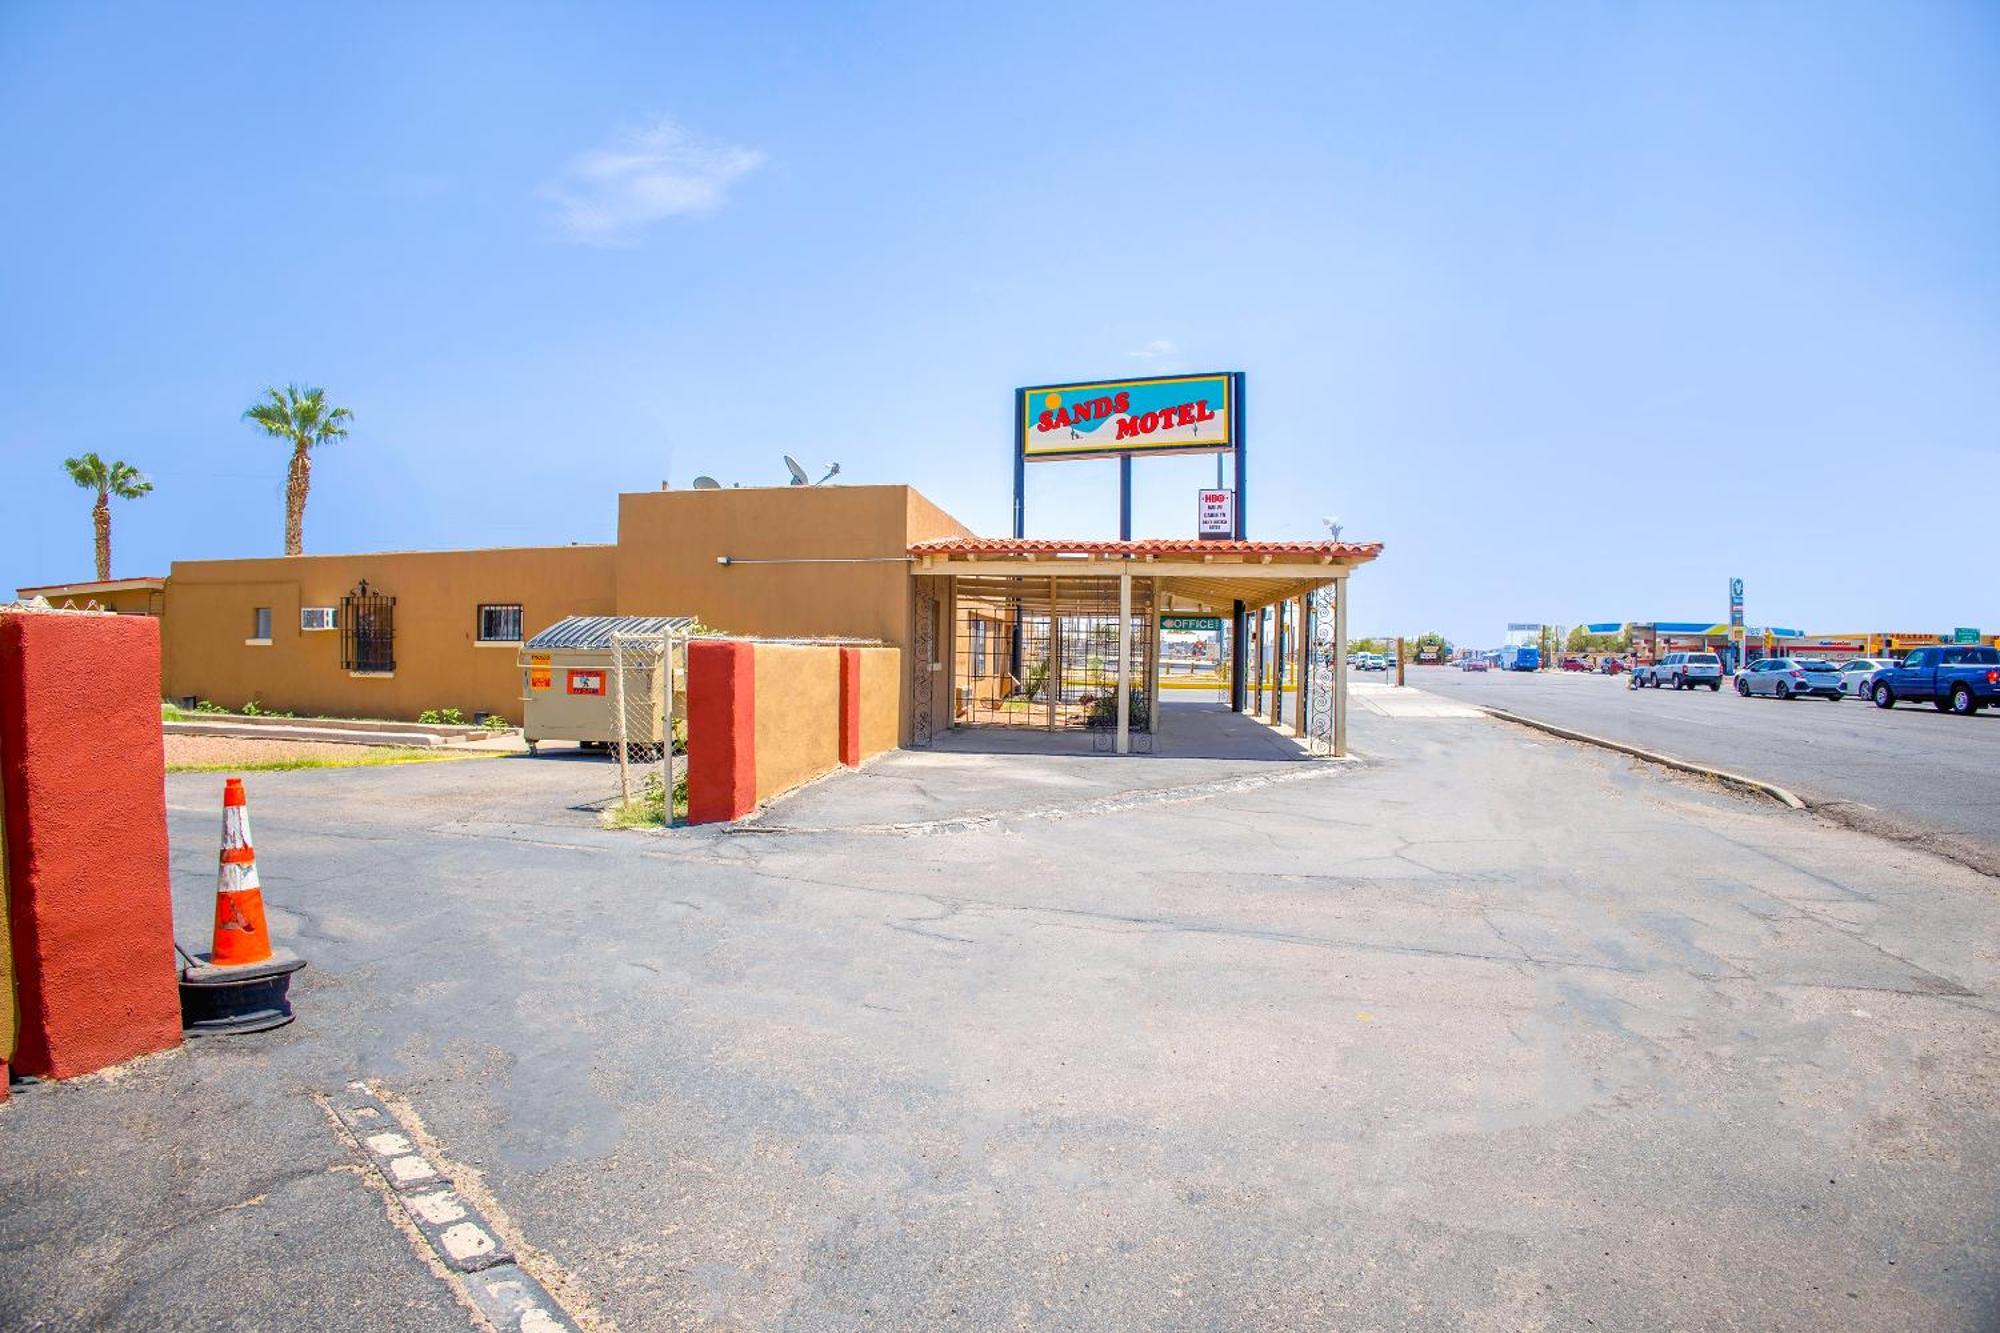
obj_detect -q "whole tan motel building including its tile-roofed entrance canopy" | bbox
[20,482,1382,755]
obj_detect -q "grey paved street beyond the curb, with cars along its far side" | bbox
[1424,667,2000,875]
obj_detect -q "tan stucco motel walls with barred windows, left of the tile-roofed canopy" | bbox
[22,486,968,723]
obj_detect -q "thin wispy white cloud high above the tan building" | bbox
[538,120,764,246]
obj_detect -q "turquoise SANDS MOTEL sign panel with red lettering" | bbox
[1016,372,1236,462]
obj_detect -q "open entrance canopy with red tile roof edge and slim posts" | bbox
[910,536,1382,755]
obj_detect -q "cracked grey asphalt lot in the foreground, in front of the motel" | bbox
[0,699,2000,1331]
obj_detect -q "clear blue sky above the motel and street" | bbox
[0,2,2000,644]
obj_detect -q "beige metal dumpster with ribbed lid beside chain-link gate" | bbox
[520,616,696,763]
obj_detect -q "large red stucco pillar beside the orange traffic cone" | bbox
[0,612,180,1079]
